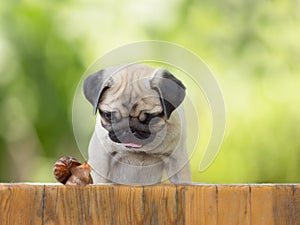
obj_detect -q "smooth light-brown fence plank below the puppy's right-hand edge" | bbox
[185,185,217,225]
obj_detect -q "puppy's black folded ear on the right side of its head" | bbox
[150,69,185,119]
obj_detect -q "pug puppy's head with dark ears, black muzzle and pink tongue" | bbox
[84,64,185,148]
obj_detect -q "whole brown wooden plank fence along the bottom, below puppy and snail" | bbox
[0,184,300,225]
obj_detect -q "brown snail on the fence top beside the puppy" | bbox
[53,156,93,186]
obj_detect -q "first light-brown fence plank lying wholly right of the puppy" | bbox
[217,185,251,225]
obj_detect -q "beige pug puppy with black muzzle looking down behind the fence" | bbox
[84,64,191,185]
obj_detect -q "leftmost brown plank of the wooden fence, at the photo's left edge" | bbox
[0,184,44,225]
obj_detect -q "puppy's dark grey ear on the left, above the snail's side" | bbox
[83,69,111,114]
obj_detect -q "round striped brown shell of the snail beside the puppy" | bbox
[53,156,81,184]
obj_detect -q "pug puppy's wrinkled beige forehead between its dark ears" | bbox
[98,65,163,117]
